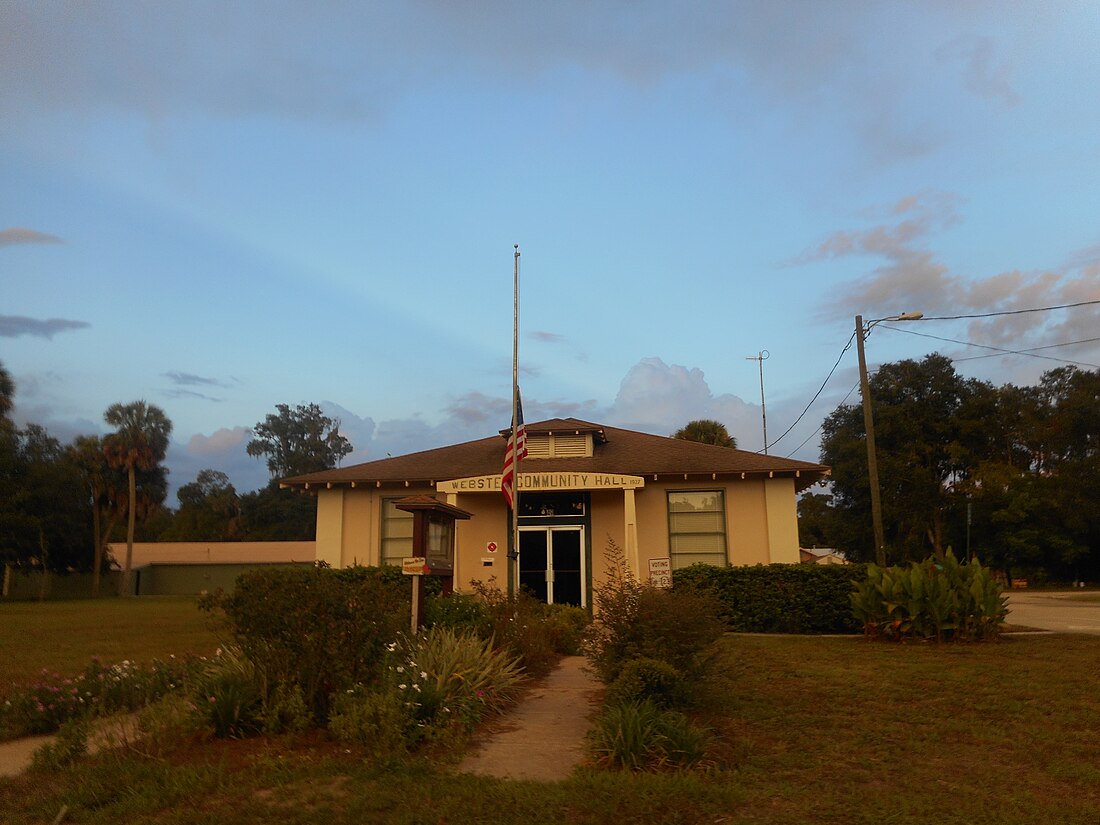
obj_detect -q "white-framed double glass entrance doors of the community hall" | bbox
[517,527,587,607]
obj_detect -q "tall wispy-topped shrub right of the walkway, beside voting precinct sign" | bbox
[585,541,724,684]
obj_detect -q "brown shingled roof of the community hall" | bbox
[282,418,829,490]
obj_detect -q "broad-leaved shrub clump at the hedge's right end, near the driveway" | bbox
[850,550,1008,641]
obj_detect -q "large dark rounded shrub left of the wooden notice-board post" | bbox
[202,568,408,721]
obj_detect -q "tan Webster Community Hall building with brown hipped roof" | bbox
[282,418,828,607]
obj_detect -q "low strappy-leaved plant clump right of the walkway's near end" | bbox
[589,702,710,771]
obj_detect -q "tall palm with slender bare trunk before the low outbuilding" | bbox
[103,400,172,596]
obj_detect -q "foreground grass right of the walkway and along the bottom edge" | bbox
[0,636,1100,825]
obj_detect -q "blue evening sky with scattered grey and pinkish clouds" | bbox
[0,0,1100,504]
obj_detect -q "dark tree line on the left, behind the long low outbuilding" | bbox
[0,364,352,594]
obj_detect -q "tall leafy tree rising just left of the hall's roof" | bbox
[248,404,352,479]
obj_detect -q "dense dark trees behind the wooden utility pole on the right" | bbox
[799,354,1100,582]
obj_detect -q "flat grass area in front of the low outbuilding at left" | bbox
[0,596,218,696]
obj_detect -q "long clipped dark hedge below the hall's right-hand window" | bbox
[672,564,867,634]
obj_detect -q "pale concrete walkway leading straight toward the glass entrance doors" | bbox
[458,656,602,782]
